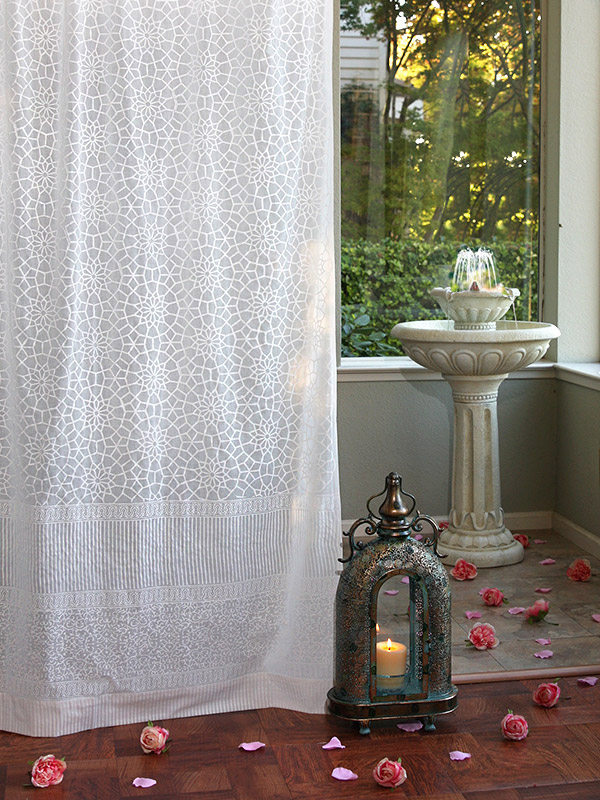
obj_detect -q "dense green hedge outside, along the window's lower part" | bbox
[341,239,538,356]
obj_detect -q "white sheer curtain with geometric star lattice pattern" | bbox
[0,0,340,736]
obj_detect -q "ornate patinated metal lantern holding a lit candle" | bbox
[327,472,457,733]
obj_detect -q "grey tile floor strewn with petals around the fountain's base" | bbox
[379,531,600,680]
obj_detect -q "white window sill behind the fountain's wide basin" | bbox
[337,356,556,382]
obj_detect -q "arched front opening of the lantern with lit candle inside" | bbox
[375,574,411,695]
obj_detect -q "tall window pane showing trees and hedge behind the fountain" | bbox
[341,0,540,355]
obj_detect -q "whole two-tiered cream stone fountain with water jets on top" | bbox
[392,250,560,567]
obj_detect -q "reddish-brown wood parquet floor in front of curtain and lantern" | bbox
[0,678,600,800]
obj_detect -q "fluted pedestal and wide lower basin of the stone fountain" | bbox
[392,321,559,567]
